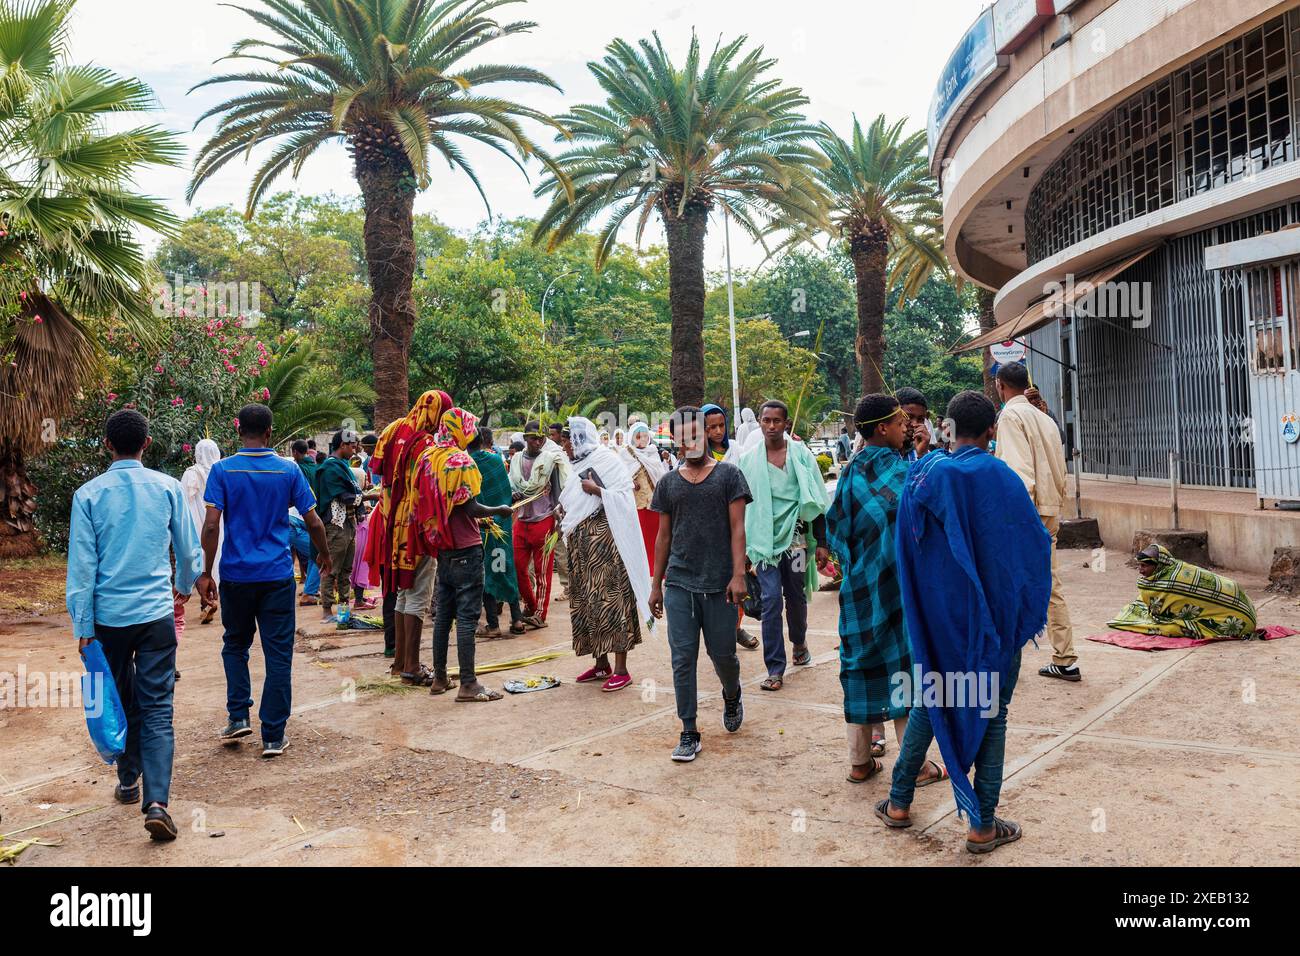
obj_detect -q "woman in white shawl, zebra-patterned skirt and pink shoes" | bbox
[560,418,653,691]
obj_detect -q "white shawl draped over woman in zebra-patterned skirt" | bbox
[560,418,654,630]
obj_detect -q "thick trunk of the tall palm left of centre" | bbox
[356,156,416,429]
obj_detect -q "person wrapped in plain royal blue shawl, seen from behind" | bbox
[875,392,1052,853]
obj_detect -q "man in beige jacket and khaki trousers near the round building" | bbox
[996,363,1082,682]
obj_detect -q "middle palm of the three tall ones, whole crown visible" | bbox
[533,34,824,405]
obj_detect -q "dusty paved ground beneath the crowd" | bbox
[0,550,1300,866]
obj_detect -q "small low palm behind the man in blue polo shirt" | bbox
[259,334,374,438]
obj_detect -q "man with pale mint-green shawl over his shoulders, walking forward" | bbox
[737,401,831,691]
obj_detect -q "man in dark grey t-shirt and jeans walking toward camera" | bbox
[650,406,751,761]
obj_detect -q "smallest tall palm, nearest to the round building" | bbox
[816,116,948,394]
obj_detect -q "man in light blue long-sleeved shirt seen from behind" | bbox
[68,408,202,840]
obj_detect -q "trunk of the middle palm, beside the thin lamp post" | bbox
[663,203,712,414]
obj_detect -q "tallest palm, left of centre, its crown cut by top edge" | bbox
[189,0,569,425]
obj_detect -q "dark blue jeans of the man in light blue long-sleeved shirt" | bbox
[95,614,176,810]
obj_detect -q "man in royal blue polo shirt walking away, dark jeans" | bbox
[198,405,330,757]
